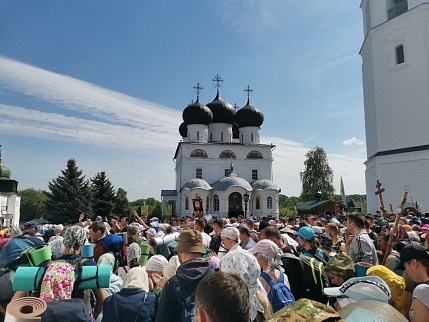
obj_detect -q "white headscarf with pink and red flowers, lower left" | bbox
[40,262,74,302]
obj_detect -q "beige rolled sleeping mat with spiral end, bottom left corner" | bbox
[4,297,47,322]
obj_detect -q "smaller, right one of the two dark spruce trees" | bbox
[91,171,116,218]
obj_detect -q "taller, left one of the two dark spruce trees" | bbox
[45,159,92,222]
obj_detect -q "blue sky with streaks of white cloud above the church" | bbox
[0,0,366,201]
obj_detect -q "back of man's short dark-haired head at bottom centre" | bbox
[195,272,250,322]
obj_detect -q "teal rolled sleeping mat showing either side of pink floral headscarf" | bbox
[12,266,110,291]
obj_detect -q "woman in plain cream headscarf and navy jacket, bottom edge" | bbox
[102,267,158,322]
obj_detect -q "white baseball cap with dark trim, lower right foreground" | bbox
[323,276,391,303]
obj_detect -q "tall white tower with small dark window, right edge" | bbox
[360,0,429,213]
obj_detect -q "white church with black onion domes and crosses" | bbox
[161,75,280,218]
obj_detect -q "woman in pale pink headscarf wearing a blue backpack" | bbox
[249,239,290,294]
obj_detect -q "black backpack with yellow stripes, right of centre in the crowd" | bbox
[299,254,329,303]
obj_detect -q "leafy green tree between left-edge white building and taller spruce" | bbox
[18,188,47,221]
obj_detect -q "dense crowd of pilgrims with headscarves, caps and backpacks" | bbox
[0,213,429,322]
